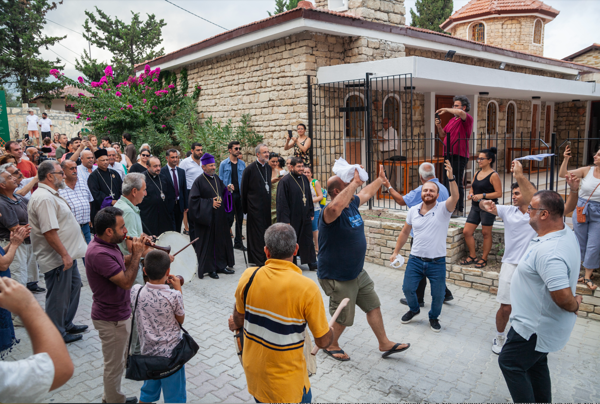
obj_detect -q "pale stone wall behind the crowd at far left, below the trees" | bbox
[7,107,84,140]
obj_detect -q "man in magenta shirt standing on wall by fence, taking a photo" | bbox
[435,95,473,217]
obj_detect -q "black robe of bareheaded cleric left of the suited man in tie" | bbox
[138,171,175,237]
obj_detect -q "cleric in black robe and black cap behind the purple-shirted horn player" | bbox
[88,149,123,230]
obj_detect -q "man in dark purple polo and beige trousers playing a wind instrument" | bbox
[85,206,148,403]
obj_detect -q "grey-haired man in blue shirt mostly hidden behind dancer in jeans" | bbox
[383,162,454,307]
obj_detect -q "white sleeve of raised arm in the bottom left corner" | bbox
[0,352,54,403]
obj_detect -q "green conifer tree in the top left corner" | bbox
[0,0,66,103]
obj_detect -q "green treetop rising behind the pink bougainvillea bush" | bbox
[81,7,167,77]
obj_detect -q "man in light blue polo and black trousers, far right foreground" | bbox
[498,191,582,403]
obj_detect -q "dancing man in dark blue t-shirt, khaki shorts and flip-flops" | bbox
[317,166,410,361]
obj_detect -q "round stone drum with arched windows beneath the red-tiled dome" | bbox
[450,16,546,56]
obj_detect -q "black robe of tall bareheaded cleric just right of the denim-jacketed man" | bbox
[240,161,271,266]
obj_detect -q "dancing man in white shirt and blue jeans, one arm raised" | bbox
[390,160,458,332]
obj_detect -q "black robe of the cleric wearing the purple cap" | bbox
[188,174,235,277]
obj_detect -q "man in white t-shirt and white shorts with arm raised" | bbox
[479,160,537,355]
